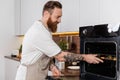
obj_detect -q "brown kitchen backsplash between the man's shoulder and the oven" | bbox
[53,36,80,53]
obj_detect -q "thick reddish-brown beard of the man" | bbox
[47,17,58,33]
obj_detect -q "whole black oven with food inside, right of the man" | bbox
[79,24,120,80]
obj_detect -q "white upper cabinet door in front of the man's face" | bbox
[58,0,80,32]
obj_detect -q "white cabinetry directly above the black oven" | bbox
[80,0,120,26]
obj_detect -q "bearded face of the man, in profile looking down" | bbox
[47,8,62,32]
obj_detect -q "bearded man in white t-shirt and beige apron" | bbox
[16,1,103,80]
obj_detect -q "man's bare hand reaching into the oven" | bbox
[82,54,103,64]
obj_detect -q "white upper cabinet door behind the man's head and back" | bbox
[21,0,45,34]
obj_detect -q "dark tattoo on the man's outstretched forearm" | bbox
[64,52,83,62]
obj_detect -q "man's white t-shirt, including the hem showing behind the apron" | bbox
[16,21,61,80]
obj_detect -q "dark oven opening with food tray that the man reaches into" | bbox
[84,42,116,78]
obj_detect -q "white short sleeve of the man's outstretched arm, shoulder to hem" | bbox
[32,22,61,57]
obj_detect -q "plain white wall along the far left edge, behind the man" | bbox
[0,0,15,80]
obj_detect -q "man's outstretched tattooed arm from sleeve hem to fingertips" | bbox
[55,51,103,64]
